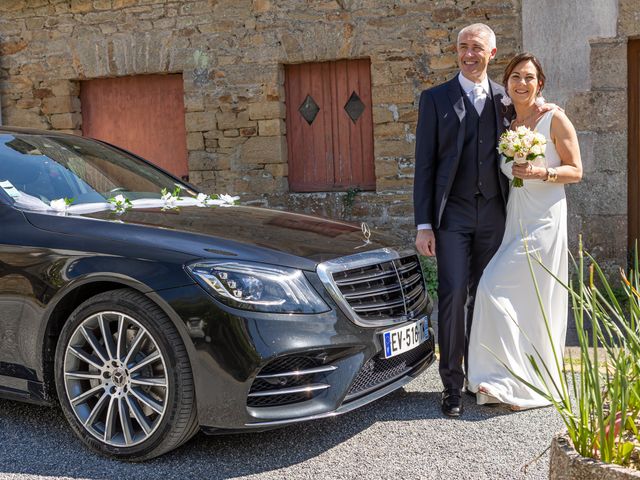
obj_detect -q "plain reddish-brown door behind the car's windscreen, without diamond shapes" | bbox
[80,75,189,178]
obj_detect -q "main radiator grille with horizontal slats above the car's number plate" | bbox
[332,255,428,322]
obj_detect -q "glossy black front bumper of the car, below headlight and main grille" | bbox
[154,285,434,433]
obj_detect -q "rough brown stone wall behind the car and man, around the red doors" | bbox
[0,0,521,242]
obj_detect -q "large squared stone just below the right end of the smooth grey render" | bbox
[591,40,627,90]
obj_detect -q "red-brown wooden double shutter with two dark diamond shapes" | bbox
[285,59,375,192]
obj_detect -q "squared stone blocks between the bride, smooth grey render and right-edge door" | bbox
[567,0,640,273]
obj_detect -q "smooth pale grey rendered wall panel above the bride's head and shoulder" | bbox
[524,0,618,105]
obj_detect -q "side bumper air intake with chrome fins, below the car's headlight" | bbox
[247,356,336,407]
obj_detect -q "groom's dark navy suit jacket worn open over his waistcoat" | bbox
[413,75,509,229]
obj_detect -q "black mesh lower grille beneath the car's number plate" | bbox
[345,338,433,402]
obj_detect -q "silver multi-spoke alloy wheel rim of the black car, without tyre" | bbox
[64,311,170,447]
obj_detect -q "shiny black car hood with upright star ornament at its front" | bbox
[25,205,402,267]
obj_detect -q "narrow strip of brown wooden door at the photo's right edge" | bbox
[627,40,640,248]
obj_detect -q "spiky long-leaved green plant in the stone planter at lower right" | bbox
[503,239,640,466]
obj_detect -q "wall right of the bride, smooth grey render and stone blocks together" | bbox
[522,0,624,271]
